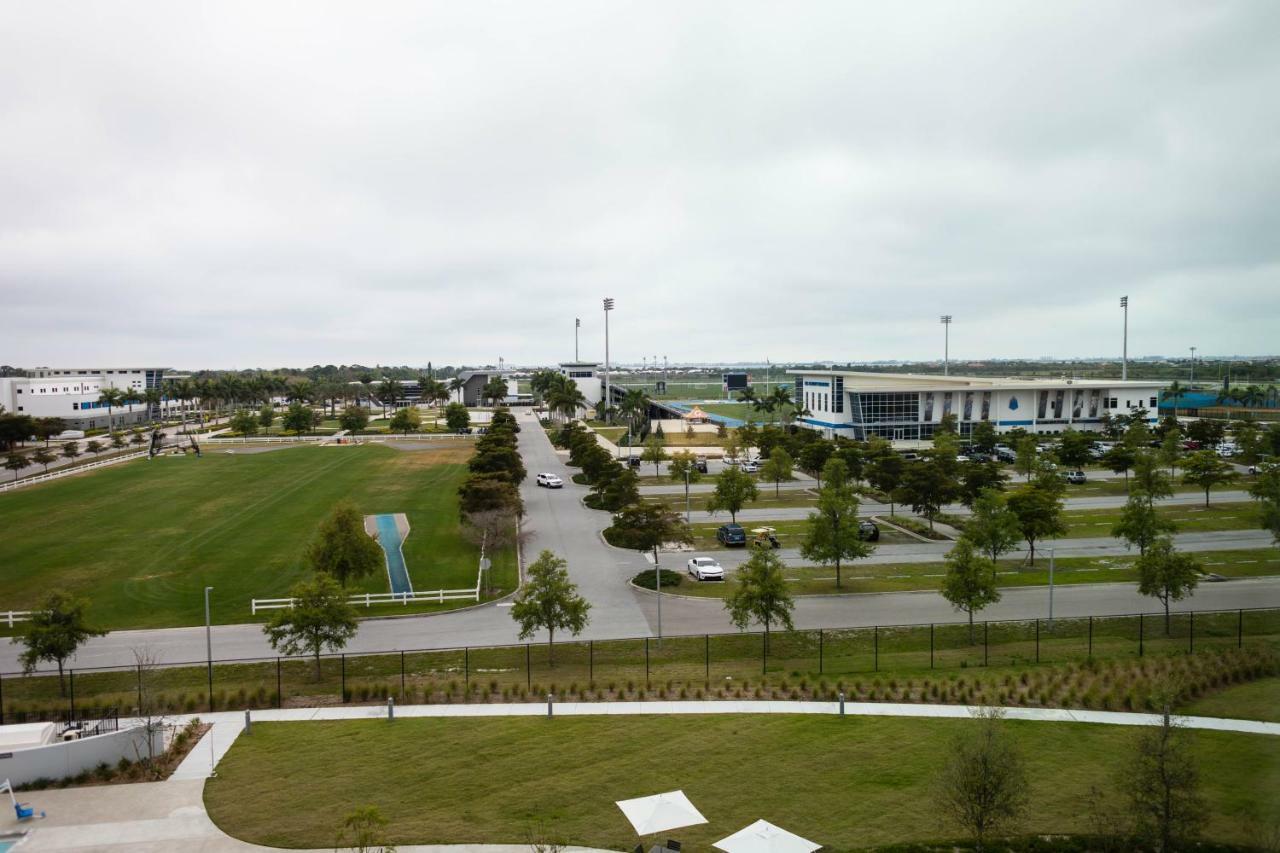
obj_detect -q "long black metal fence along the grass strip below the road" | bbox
[0,607,1280,724]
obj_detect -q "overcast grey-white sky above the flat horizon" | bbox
[0,0,1280,368]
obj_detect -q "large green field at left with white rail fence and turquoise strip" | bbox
[0,442,515,629]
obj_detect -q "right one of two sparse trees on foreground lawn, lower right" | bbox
[1121,698,1207,853]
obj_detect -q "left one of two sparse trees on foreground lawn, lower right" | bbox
[934,708,1028,853]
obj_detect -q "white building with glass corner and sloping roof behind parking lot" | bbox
[787,369,1162,441]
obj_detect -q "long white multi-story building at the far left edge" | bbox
[0,368,169,429]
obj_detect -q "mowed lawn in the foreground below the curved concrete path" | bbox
[205,715,1280,850]
